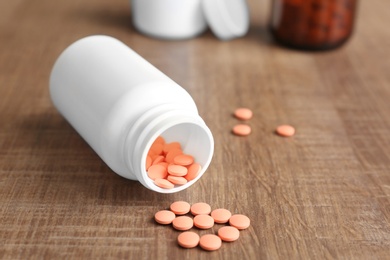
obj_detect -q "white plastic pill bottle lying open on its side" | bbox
[50,36,214,193]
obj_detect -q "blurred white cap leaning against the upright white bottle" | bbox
[202,0,249,40]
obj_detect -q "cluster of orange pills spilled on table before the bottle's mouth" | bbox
[154,201,250,251]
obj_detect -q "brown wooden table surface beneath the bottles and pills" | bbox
[0,0,390,259]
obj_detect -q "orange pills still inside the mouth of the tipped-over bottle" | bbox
[145,136,202,189]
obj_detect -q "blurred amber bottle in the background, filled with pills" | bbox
[271,0,358,50]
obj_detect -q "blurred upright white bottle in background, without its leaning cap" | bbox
[131,0,207,40]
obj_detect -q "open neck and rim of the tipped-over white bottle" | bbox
[124,105,214,193]
